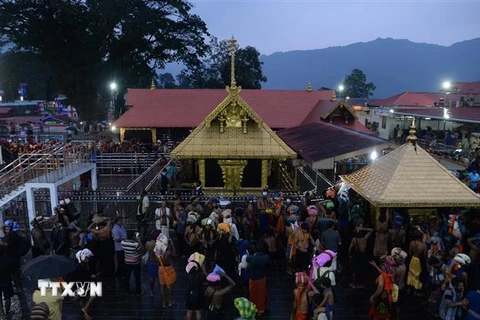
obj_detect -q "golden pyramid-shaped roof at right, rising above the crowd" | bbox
[341,142,480,208]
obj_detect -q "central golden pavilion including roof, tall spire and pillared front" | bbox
[170,37,297,192]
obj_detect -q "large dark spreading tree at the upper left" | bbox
[0,0,208,120]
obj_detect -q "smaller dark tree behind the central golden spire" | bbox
[177,38,267,89]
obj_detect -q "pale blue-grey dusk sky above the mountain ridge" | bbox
[190,0,480,54]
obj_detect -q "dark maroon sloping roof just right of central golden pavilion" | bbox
[277,121,388,162]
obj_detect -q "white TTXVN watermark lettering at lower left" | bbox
[38,280,103,297]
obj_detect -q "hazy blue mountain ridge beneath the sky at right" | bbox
[260,38,480,98]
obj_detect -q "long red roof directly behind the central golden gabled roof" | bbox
[114,89,332,129]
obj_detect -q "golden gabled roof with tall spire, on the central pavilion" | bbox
[170,37,297,159]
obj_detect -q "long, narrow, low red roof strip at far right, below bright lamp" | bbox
[394,107,480,123]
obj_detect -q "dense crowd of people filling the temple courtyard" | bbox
[0,188,480,320]
